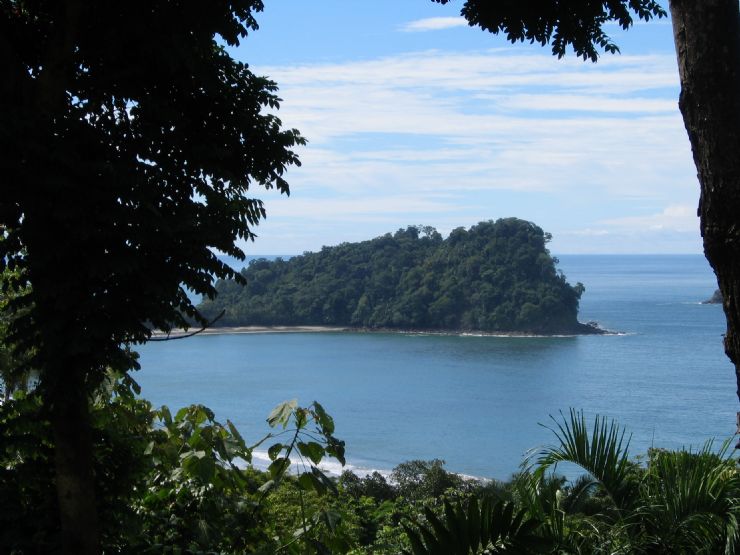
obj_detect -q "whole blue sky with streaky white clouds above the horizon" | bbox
[231,0,701,255]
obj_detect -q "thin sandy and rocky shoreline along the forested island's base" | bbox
[152,323,622,339]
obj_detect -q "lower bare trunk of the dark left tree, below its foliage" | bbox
[47,369,100,555]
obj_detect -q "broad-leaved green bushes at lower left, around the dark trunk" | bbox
[0,374,344,554]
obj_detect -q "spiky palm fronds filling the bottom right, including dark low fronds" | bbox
[404,410,740,555]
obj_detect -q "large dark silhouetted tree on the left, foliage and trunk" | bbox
[0,0,304,554]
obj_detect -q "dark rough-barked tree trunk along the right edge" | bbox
[670,0,740,416]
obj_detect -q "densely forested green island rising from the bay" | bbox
[200,218,597,334]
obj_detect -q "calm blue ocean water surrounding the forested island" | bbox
[135,255,737,478]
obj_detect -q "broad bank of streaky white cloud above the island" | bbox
[249,50,698,252]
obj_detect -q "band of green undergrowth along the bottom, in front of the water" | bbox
[0,375,740,555]
